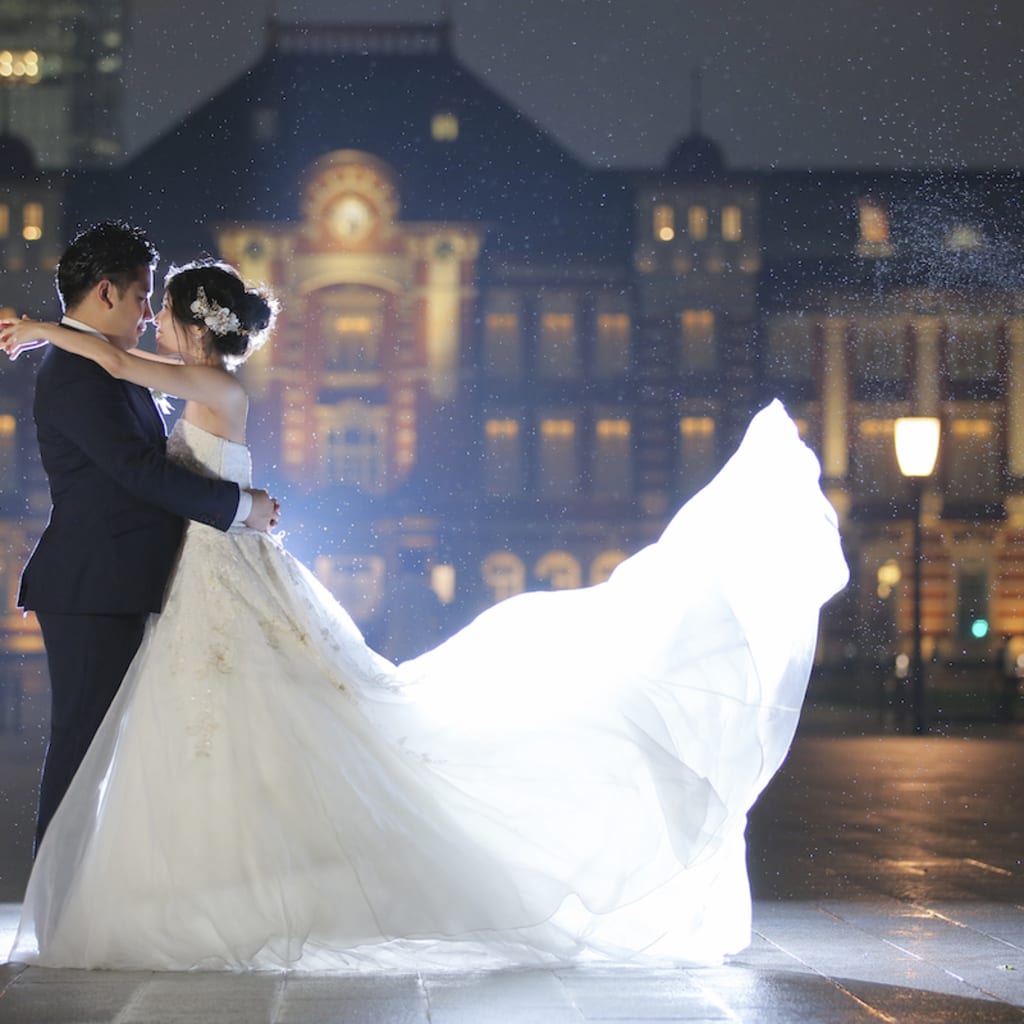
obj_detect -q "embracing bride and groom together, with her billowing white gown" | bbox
[0,224,846,970]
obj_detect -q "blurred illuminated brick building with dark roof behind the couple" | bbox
[2,26,1024,704]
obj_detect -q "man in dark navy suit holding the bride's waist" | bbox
[18,223,274,850]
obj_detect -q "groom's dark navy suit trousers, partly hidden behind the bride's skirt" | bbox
[36,612,150,850]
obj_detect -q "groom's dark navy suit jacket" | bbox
[18,346,239,614]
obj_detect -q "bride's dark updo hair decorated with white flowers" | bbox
[164,260,278,368]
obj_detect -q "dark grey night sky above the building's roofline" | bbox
[126,0,1024,169]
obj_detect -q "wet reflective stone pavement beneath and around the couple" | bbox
[0,708,1024,1024]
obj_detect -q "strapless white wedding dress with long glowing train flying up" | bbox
[11,402,847,971]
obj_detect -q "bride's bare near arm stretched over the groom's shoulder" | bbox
[0,319,244,408]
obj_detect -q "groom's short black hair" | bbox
[57,220,160,310]
